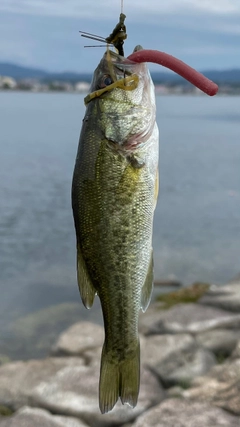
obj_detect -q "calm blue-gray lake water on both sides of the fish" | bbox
[0,92,240,362]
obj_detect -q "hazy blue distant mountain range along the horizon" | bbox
[0,63,240,84]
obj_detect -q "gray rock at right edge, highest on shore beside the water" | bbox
[198,278,240,313]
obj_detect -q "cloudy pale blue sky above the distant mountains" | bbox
[0,0,240,73]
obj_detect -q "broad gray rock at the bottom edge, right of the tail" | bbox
[133,399,240,427]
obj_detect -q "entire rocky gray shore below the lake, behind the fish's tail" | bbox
[0,277,240,427]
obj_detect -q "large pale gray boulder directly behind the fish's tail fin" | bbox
[0,357,165,427]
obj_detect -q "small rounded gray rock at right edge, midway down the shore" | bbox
[196,329,240,357]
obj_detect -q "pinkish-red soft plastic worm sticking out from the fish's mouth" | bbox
[127,49,218,96]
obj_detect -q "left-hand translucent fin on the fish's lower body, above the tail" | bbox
[77,244,97,309]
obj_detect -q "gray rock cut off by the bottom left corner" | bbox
[0,406,87,427]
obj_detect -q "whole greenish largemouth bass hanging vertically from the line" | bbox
[72,48,158,413]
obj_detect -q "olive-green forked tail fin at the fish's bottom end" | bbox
[99,342,140,414]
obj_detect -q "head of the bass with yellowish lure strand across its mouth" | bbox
[86,48,156,150]
